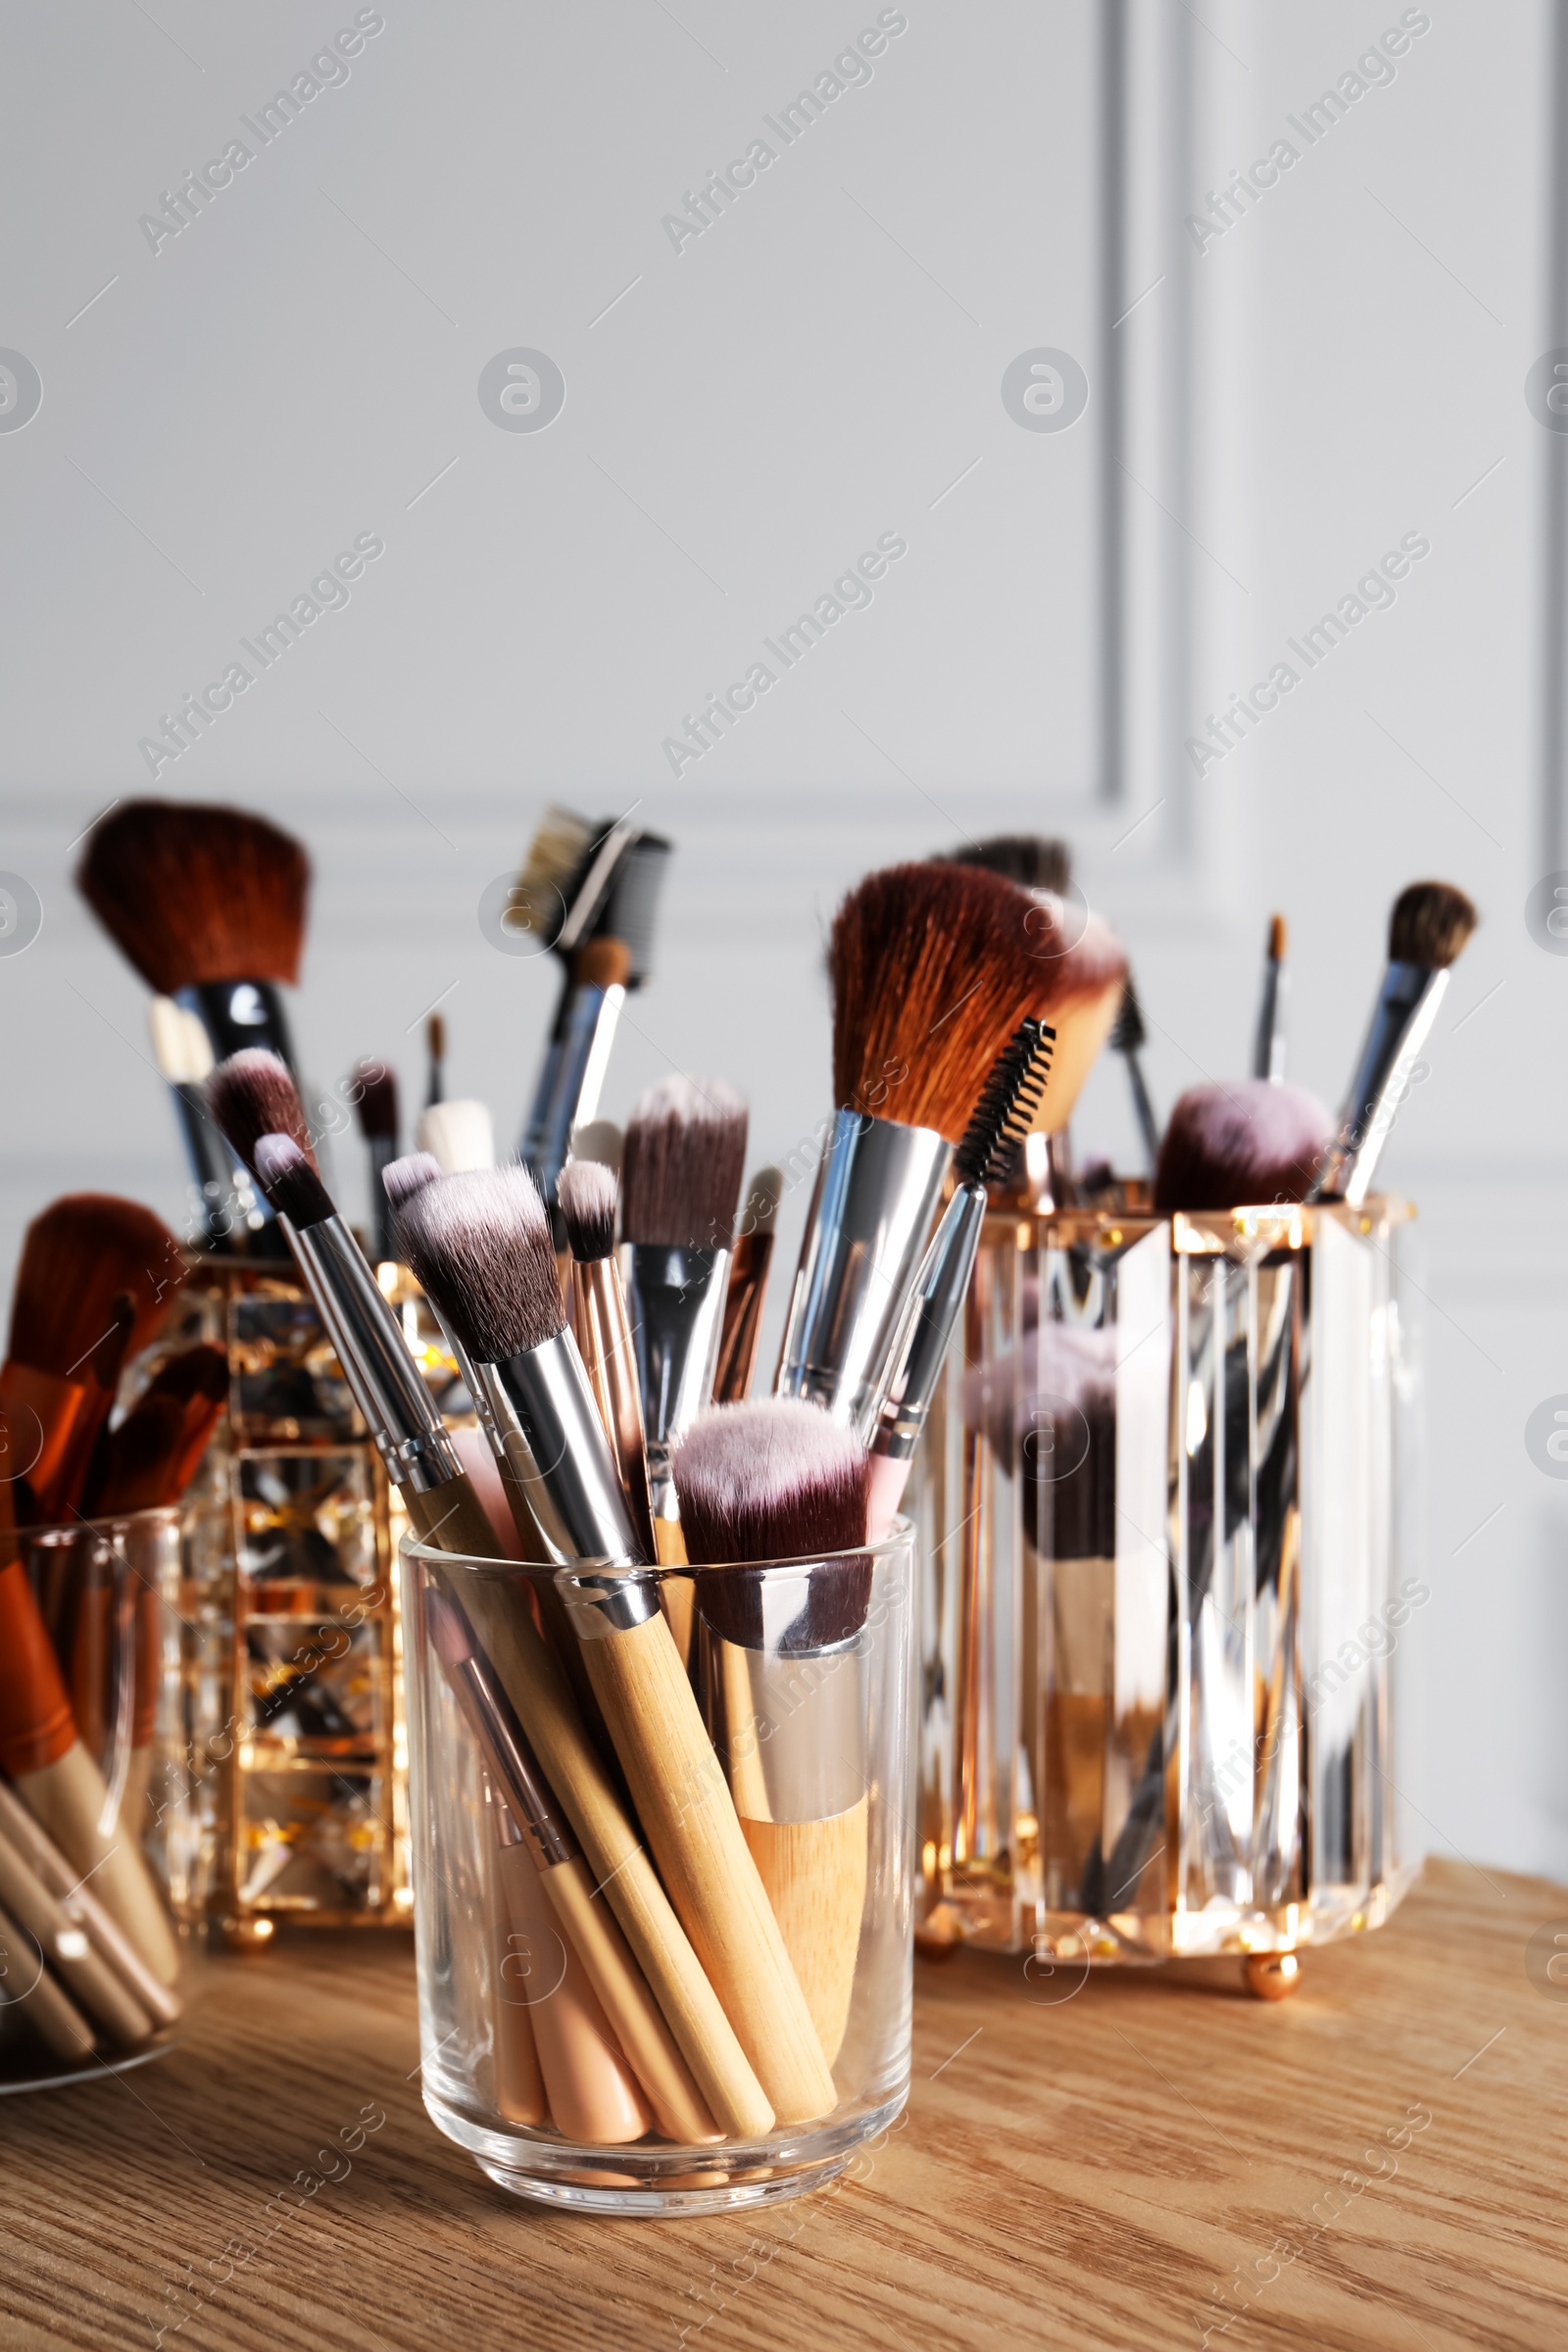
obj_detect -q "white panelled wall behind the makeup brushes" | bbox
[0,0,1568,1877]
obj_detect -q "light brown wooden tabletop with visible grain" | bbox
[0,1863,1568,2352]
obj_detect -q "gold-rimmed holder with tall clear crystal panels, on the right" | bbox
[912,1198,1429,1997]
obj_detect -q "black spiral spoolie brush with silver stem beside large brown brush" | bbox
[867,1021,1055,1543]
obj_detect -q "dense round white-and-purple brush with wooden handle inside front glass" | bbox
[674,1397,872,2065]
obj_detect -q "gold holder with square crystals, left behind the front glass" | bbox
[146,1256,466,1947]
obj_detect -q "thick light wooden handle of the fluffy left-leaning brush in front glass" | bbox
[583,1616,839,2124]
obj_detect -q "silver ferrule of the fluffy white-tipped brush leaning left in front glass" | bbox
[475,1331,659,1640]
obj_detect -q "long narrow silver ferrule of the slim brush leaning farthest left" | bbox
[277,1216,464,1494]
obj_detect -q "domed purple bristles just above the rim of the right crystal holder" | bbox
[1154,1077,1333,1213]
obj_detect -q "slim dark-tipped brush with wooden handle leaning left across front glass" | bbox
[208,1072,773,2140]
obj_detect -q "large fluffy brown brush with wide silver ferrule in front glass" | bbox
[776,863,1054,1437]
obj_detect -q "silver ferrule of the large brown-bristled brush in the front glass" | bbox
[776,1110,953,1442]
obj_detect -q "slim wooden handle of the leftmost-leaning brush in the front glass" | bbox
[405,1480,773,2140]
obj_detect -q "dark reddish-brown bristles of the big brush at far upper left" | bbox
[75,800,311,998]
